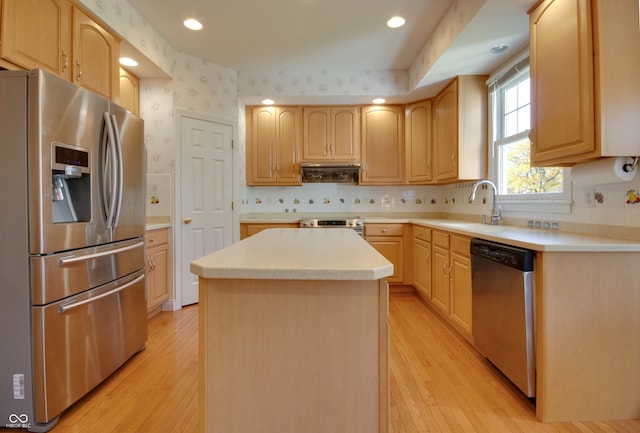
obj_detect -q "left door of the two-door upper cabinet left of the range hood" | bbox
[247,107,277,185]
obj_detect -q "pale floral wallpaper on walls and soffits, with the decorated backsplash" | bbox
[80,0,640,227]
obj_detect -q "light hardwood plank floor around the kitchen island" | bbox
[37,293,640,433]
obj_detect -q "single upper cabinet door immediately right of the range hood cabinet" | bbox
[360,106,404,185]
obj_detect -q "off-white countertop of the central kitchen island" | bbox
[191,228,393,280]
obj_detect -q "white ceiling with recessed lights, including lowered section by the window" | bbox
[128,0,536,103]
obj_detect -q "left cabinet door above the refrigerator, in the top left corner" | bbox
[0,0,71,80]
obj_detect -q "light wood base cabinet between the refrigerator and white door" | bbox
[145,228,170,316]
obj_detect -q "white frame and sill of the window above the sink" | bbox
[487,54,571,213]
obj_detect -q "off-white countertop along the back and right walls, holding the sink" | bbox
[241,214,640,252]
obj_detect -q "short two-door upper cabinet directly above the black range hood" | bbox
[302,106,360,162]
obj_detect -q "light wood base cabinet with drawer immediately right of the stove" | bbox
[364,223,404,283]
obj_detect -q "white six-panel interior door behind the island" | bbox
[178,116,233,306]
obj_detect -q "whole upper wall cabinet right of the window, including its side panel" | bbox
[529,0,640,166]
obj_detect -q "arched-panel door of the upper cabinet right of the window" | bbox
[530,0,596,165]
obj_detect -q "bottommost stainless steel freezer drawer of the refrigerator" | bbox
[31,271,147,423]
